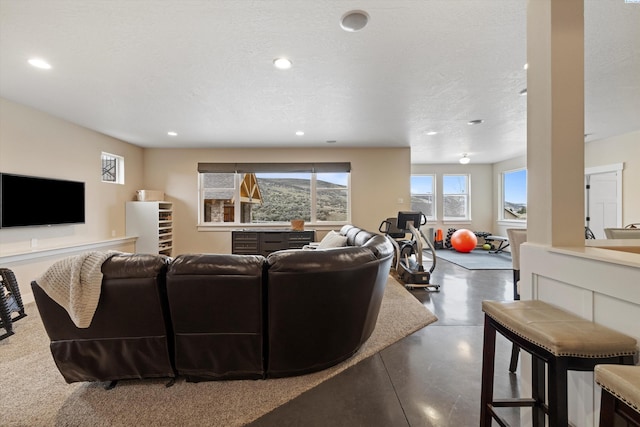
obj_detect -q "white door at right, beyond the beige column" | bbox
[585,171,622,239]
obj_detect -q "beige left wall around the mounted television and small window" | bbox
[0,98,143,300]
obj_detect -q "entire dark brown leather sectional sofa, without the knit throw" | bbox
[31,225,393,383]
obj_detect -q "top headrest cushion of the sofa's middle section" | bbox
[167,254,265,276]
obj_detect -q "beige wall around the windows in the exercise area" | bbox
[411,164,495,233]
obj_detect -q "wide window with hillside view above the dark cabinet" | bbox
[198,163,350,224]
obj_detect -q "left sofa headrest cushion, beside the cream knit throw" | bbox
[101,254,170,279]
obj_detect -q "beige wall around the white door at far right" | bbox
[584,131,640,225]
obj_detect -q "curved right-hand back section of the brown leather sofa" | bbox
[266,232,393,377]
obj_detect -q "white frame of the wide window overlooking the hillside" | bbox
[198,172,351,228]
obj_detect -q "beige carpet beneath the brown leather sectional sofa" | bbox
[0,278,437,426]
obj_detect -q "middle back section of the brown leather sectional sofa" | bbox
[167,254,265,381]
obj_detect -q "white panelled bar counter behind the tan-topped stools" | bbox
[520,239,640,426]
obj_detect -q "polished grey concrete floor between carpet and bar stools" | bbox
[250,259,519,427]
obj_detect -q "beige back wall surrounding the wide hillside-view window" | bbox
[144,147,410,254]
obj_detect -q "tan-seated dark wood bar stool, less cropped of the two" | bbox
[480,300,638,427]
